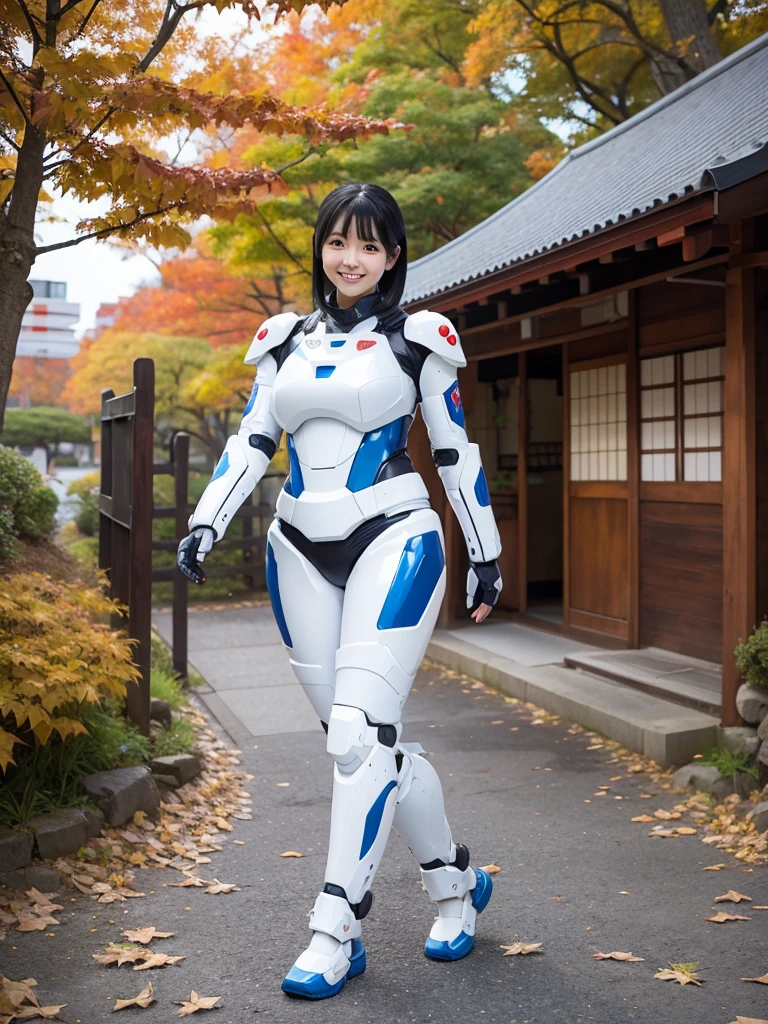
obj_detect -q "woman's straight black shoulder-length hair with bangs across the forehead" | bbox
[312,181,408,319]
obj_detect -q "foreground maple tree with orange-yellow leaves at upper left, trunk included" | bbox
[0,0,409,425]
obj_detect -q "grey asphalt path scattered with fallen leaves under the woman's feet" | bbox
[0,651,768,1024]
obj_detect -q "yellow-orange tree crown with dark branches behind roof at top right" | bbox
[463,0,768,134]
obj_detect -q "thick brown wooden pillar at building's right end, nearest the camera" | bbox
[723,268,757,725]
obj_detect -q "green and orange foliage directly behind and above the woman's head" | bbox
[210,0,561,284]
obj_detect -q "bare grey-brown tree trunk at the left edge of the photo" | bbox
[0,125,45,431]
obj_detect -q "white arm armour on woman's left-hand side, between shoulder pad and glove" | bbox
[189,352,282,541]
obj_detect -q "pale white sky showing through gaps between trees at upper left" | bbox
[30,7,276,338]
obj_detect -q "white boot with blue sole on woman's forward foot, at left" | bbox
[281,893,366,999]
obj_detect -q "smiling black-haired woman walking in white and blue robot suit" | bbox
[178,184,502,998]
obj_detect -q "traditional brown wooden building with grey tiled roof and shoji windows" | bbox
[404,29,768,724]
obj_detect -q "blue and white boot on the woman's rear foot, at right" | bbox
[421,844,494,961]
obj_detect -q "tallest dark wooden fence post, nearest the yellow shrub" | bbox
[127,359,155,735]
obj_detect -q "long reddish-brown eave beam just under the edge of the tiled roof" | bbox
[407,194,715,312]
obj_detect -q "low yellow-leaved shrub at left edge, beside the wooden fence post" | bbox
[0,572,139,772]
